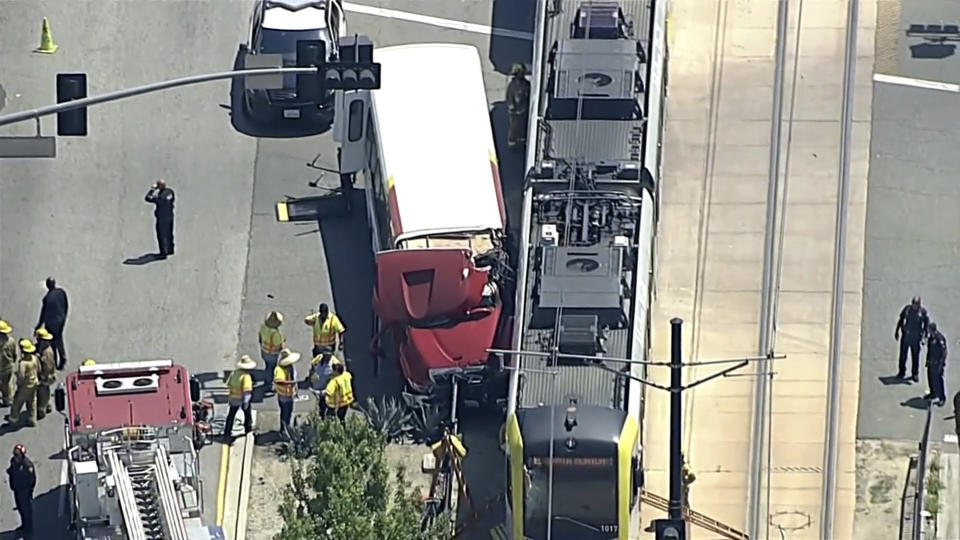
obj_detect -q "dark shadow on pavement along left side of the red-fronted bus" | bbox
[319,189,401,403]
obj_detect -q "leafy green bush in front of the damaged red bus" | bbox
[275,415,443,540]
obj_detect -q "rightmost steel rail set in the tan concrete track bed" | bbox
[820,0,860,540]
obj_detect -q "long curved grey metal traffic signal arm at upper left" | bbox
[0,67,317,126]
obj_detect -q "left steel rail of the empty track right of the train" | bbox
[747,0,790,538]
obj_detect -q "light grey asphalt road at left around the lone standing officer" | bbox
[0,0,256,538]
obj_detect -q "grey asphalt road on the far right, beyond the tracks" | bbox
[857,0,960,441]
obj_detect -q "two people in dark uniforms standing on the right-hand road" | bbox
[893,296,947,407]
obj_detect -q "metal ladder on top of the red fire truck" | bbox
[106,445,188,540]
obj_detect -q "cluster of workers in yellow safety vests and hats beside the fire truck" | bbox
[223,304,355,441]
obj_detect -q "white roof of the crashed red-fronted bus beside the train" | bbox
[372,43,506,240]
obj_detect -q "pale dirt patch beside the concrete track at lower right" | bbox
[853,440,917,540]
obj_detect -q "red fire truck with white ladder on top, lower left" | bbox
[54,360,224,540]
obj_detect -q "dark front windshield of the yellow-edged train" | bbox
[524,457,617,538]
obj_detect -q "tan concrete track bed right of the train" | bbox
[643,0,876,539]
